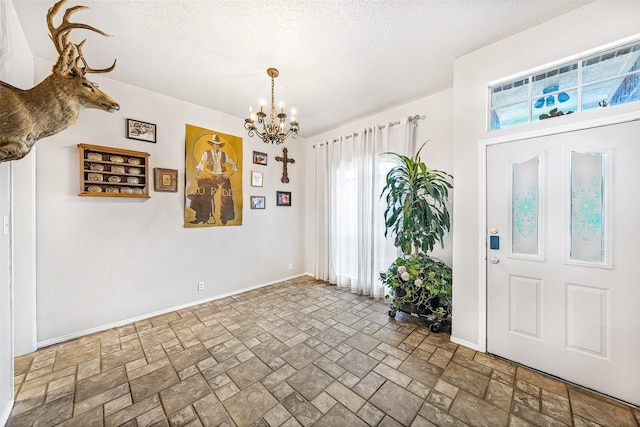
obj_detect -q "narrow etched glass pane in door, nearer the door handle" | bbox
[511,156,540,255]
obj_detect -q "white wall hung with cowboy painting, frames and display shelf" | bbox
[36,59,305,345]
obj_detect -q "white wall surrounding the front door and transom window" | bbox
[452,1,640,348]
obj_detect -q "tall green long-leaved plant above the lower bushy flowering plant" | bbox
[381,144,453,255]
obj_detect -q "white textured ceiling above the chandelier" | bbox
[13,0,590,137]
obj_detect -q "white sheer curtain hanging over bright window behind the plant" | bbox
[315,119,417,298]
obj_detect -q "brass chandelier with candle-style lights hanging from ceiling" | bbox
[244,68,300,144]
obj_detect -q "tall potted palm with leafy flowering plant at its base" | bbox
[380,144,453,332]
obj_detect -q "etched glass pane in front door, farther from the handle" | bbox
[570,151,604,264]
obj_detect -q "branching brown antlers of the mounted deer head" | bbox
[47,0,116,75]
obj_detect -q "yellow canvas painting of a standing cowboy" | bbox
[184,125,242,228]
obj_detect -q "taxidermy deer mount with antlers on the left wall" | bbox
[0,0,120,162]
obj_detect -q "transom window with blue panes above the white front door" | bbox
[489,41,640,130]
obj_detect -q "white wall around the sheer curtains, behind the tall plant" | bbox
[305,89,456,274]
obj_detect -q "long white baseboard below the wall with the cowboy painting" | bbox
[37,273,313,350]
